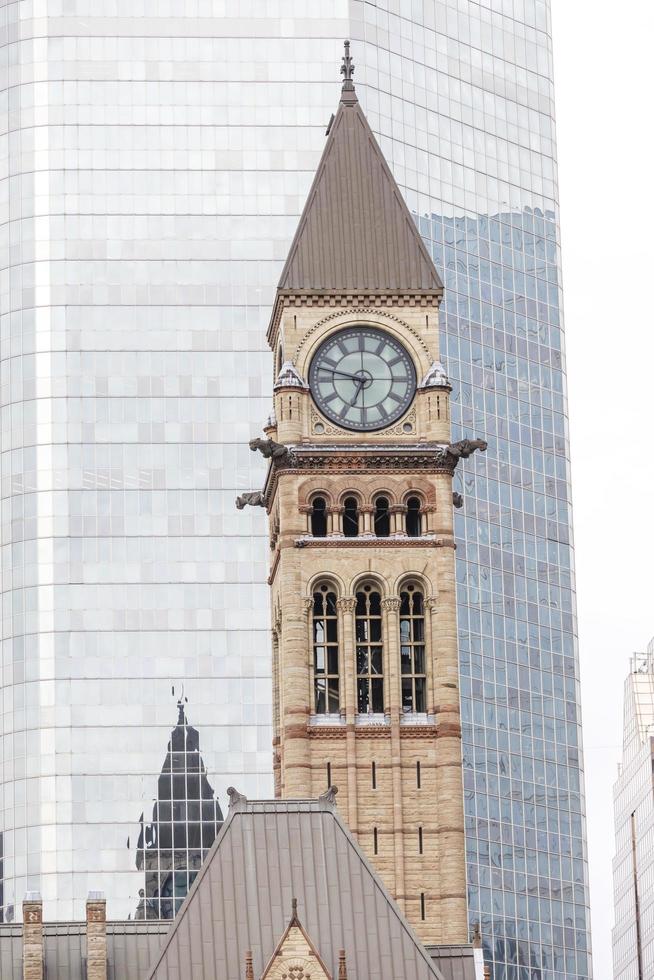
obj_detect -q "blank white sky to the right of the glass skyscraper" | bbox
[552,0,654,980]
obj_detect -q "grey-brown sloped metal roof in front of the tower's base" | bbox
[148,800,443,980]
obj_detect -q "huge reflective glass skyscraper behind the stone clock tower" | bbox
[0,0,590,980]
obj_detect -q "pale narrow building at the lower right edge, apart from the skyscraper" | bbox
[613,640,654,980]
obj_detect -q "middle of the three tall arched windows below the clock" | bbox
[355,585,384,715]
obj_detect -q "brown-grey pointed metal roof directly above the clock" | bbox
[278,87,443,296]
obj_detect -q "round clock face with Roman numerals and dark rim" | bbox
[309,325,416,431]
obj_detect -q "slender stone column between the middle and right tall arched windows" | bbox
[382,596,405,911]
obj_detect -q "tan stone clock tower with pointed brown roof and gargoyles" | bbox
[242,42,485,944]
